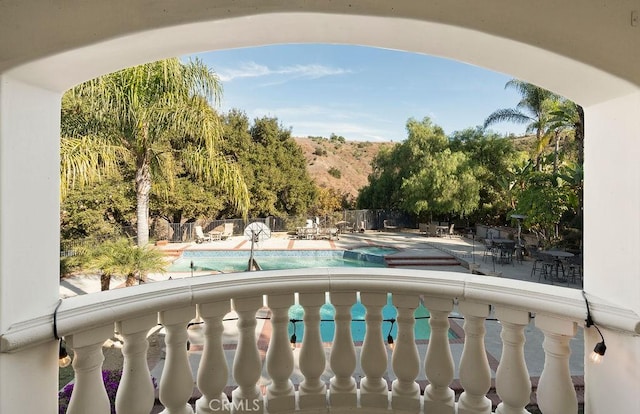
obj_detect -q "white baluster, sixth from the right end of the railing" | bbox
[360,292,389,408]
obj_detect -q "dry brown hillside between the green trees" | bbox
[295,138,393,198]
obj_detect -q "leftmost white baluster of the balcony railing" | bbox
[66,324,113,414]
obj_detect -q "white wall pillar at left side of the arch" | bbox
[0,76,60,413]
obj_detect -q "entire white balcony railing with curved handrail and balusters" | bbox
[2,268,640,414]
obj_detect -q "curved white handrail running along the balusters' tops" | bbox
[0,268,640,352]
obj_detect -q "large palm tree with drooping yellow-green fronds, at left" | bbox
[61,58,249,246]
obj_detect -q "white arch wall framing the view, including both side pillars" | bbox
[0,0,640,413]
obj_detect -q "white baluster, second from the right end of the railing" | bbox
[496,306,531,414]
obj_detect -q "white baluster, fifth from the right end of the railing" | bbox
[391,295,420,412]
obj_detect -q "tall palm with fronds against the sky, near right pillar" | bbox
[484,79,560,169]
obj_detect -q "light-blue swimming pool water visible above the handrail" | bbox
[168,249,388,273]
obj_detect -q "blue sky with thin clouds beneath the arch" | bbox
[185,44,524,141]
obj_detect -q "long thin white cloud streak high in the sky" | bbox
[218,62,353,82]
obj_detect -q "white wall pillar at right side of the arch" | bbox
[584,92,640,414]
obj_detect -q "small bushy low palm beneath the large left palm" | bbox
[89,238,167,290]
